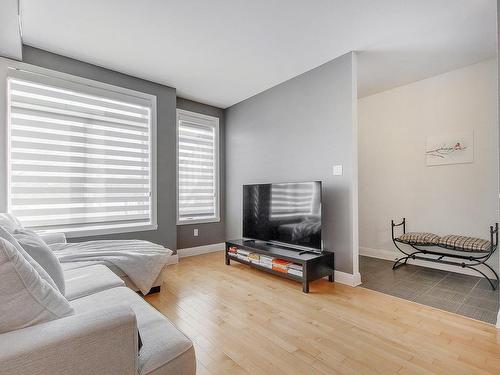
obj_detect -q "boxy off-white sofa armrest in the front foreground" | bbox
[0,306,138,375]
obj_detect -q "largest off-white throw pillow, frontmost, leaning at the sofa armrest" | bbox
[0,238,74,333]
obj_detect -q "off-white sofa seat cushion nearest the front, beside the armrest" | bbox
[71,287,192,375]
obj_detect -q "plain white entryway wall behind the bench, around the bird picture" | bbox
[358,59,499,271]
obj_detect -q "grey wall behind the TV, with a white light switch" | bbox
[226,53,358,273]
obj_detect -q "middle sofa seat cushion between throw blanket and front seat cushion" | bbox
[64,264,125,301]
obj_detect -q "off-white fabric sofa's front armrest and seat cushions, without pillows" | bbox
[0,251,196,375]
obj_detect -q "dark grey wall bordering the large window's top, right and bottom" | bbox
[23,46,177,250]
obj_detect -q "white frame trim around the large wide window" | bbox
[0,58,158,238]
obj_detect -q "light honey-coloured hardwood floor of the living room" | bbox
[146,252,500,375]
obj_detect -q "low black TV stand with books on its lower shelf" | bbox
[225,239,335,293]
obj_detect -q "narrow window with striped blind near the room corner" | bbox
[177,110,220,224]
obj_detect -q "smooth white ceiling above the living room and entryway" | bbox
[21,0,496,108]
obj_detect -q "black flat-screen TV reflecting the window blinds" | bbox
[243,181,321,251]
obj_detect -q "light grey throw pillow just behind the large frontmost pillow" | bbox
[13,229,66,295]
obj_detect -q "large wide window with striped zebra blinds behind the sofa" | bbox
[7,69,156,236]
